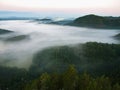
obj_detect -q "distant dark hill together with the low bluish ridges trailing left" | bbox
[35,14,120,29]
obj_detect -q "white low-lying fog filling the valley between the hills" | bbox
[0,20,119,67]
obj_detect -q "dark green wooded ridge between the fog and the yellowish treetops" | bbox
[30,42,120,77]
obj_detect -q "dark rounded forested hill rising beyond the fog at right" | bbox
[71,14,120,29]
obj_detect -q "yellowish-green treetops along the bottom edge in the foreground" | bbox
[25,66,120,90]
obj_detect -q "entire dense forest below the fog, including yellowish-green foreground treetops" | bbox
[0,42,120,90]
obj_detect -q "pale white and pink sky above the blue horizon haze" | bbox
[0,0,120,16]
